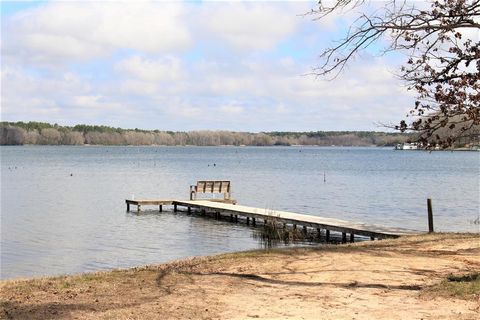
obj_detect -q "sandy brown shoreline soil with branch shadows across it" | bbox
[0,234,480,319]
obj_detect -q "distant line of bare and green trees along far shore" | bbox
[0,122,411,146]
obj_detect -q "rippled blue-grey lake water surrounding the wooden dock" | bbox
[0,146,480,278]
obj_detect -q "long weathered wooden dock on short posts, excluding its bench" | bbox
[125,200,424,242]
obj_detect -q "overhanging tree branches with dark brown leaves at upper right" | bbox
[311,0,480,148]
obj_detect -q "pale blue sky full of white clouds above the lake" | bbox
[1,1,414,132]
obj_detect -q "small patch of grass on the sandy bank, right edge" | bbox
[423,273,480,300]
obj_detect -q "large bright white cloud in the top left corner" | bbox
[4,2,191,63]
